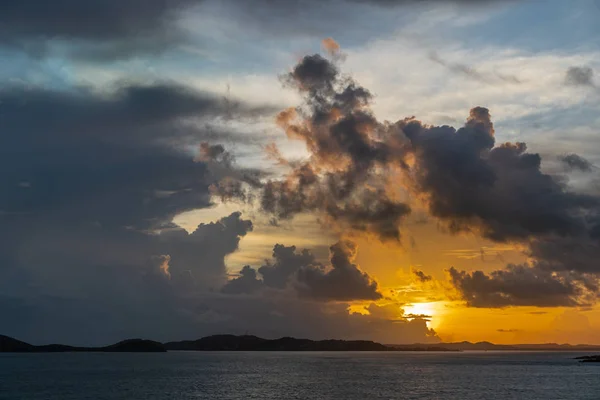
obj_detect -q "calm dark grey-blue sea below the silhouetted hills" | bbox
[0,352,600,400]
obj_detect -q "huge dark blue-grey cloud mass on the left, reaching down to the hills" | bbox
[0,78,270,343]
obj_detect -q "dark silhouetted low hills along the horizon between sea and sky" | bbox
[0,335,600,353]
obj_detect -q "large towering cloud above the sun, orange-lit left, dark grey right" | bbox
[247,51,599,241]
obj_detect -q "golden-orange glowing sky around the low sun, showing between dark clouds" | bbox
[175,204,600,344]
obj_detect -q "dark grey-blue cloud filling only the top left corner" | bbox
[0,0,202,58]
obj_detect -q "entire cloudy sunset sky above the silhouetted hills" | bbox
[0,0,600,345]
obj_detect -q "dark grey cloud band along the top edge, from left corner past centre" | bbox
[0,0,510,61]
